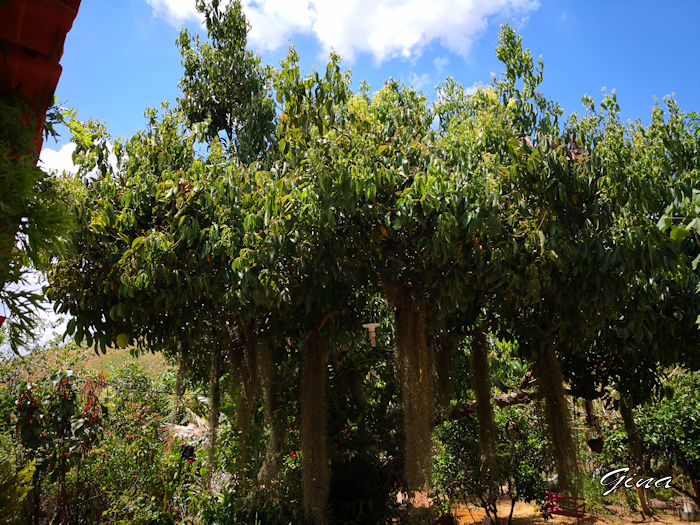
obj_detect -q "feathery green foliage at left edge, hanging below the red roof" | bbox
[0,92,71,351]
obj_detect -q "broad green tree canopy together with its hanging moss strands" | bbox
[41,1,700,523]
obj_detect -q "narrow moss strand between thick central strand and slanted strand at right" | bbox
[471,328,498,517]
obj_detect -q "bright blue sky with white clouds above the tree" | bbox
[42,0,700,169]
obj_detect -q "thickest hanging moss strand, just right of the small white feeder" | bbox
[392,288,435,492]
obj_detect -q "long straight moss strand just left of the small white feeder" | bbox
[301,330,330,525]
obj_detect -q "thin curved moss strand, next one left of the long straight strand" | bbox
[258,344,282,483]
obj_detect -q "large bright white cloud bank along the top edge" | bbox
[147,0,539,62]
